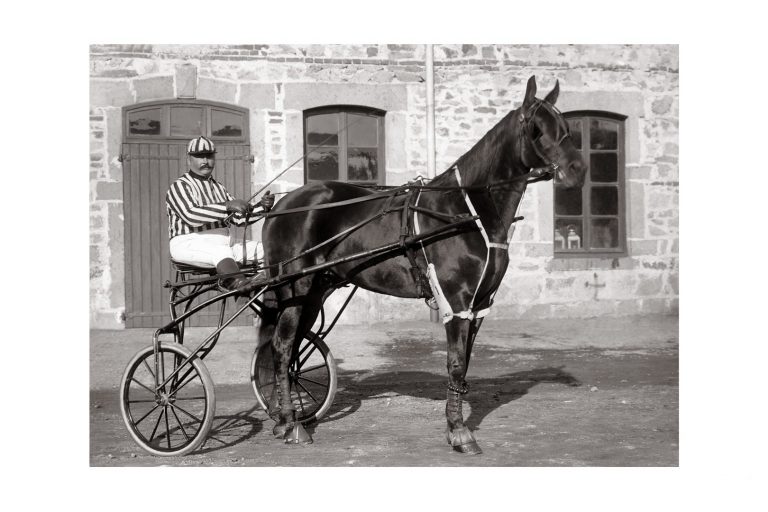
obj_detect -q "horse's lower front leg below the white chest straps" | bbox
[445,317,482,454]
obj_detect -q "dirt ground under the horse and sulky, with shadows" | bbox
[90,317,679,466]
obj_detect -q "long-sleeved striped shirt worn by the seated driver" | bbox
[165,171,258,239]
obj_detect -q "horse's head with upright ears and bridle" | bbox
[517,76,587,188]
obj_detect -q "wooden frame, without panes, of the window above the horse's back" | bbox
[302,105,387,185]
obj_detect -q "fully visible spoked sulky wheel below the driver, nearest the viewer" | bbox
[120,342,216,456]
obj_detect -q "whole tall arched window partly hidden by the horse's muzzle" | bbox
[554,110,627,257]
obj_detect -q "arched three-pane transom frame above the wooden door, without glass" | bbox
[123,99,250,143]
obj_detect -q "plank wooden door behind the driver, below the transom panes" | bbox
[122,141,253,327]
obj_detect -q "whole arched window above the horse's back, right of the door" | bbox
[304,105,386,185]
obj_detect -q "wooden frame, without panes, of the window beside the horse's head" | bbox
[552,110,629,259]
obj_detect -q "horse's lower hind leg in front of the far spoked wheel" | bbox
[272,307,312,444]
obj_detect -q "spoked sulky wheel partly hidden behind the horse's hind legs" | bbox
[251,336,336,424]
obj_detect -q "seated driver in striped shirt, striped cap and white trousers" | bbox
[165,136,275,290]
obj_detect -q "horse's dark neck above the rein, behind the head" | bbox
[432,109,518,185]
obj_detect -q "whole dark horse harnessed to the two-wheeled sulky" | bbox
[259,77,586,453]
